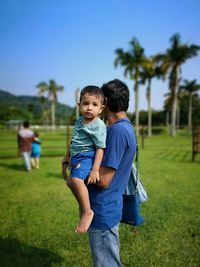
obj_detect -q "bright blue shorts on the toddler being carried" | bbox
[70,151,95,180]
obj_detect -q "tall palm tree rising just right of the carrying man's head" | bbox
[114,38,150,135]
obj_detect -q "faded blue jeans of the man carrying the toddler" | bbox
[88,225,121,267]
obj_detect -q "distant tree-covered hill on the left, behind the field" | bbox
[0,90,74,123]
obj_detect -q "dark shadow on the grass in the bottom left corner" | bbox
[0,238,63,267]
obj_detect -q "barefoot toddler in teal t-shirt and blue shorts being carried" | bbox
[62,86,106,233]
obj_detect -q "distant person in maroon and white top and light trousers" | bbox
[17,121,34,171]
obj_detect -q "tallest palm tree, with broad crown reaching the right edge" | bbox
[156,34,200,136]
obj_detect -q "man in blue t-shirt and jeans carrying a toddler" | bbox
[88,79,136,267]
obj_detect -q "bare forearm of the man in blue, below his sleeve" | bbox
[95,167,116,189]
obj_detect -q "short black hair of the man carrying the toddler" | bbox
[101,79,129,112]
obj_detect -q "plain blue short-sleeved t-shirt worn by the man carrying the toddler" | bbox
[88,118,136,229]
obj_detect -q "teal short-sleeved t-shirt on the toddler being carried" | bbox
[70,116,106,156]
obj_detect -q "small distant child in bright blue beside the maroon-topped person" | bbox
[31,132,41,169]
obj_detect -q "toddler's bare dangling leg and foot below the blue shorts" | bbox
[68,177,94,233]
